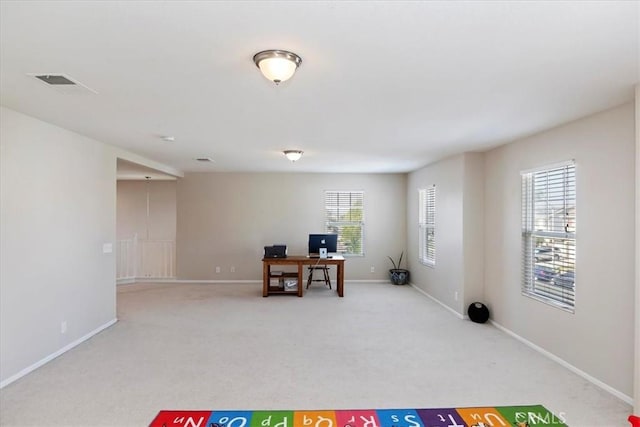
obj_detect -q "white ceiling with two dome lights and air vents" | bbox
[0,1,640,177]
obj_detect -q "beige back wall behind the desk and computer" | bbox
[177,173,406,280]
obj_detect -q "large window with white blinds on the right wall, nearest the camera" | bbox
[522,161,576,312]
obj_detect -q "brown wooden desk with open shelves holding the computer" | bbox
[262,255,344,297]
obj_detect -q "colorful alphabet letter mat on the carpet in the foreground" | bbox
[150,405,567,427]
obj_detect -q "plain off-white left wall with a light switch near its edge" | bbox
[0,107,116,384]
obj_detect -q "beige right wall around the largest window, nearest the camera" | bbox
[484,103,635,397]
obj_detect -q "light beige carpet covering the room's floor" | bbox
[0,283,631,427]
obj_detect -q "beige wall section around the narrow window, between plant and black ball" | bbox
[407,153,484,316]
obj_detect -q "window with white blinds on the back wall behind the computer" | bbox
[324,191,364,255]
